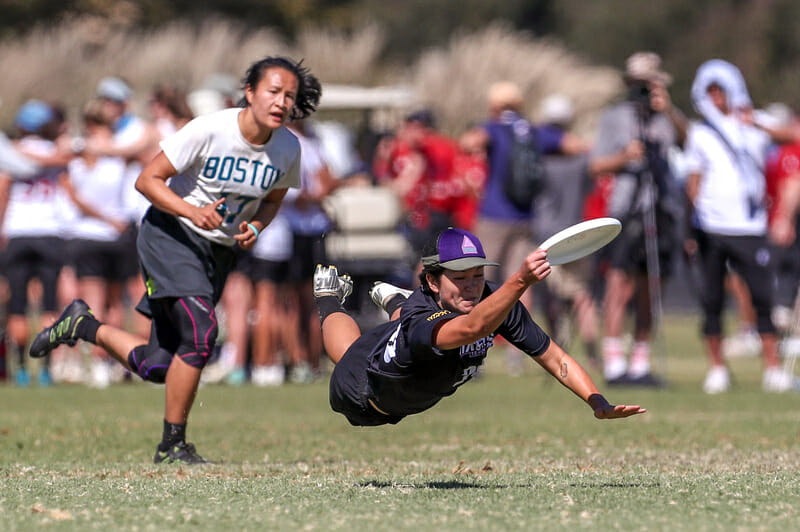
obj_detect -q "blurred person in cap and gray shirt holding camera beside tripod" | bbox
[589,52,687,386]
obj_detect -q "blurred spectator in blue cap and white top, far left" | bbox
[0,100,70,386]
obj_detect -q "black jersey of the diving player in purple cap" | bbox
[351,283,550,416]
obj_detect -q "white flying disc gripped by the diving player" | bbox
[539,218,622,266]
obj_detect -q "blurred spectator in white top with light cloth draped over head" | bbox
[686,59,792,393]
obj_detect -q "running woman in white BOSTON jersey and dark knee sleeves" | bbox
[30,57,321,464]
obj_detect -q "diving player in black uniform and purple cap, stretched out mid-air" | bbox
[314,228,645,426]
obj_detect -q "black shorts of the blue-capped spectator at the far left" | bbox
[3,236,66,315]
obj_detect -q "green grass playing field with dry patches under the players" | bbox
[0,316,800,531]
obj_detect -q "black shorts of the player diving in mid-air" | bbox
[329,336,404,427]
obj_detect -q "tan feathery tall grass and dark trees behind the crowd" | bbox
[0,0,800,134]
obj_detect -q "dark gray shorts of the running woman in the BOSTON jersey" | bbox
[136,207,236,316]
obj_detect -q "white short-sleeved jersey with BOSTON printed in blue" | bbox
[161,108,300,246]
